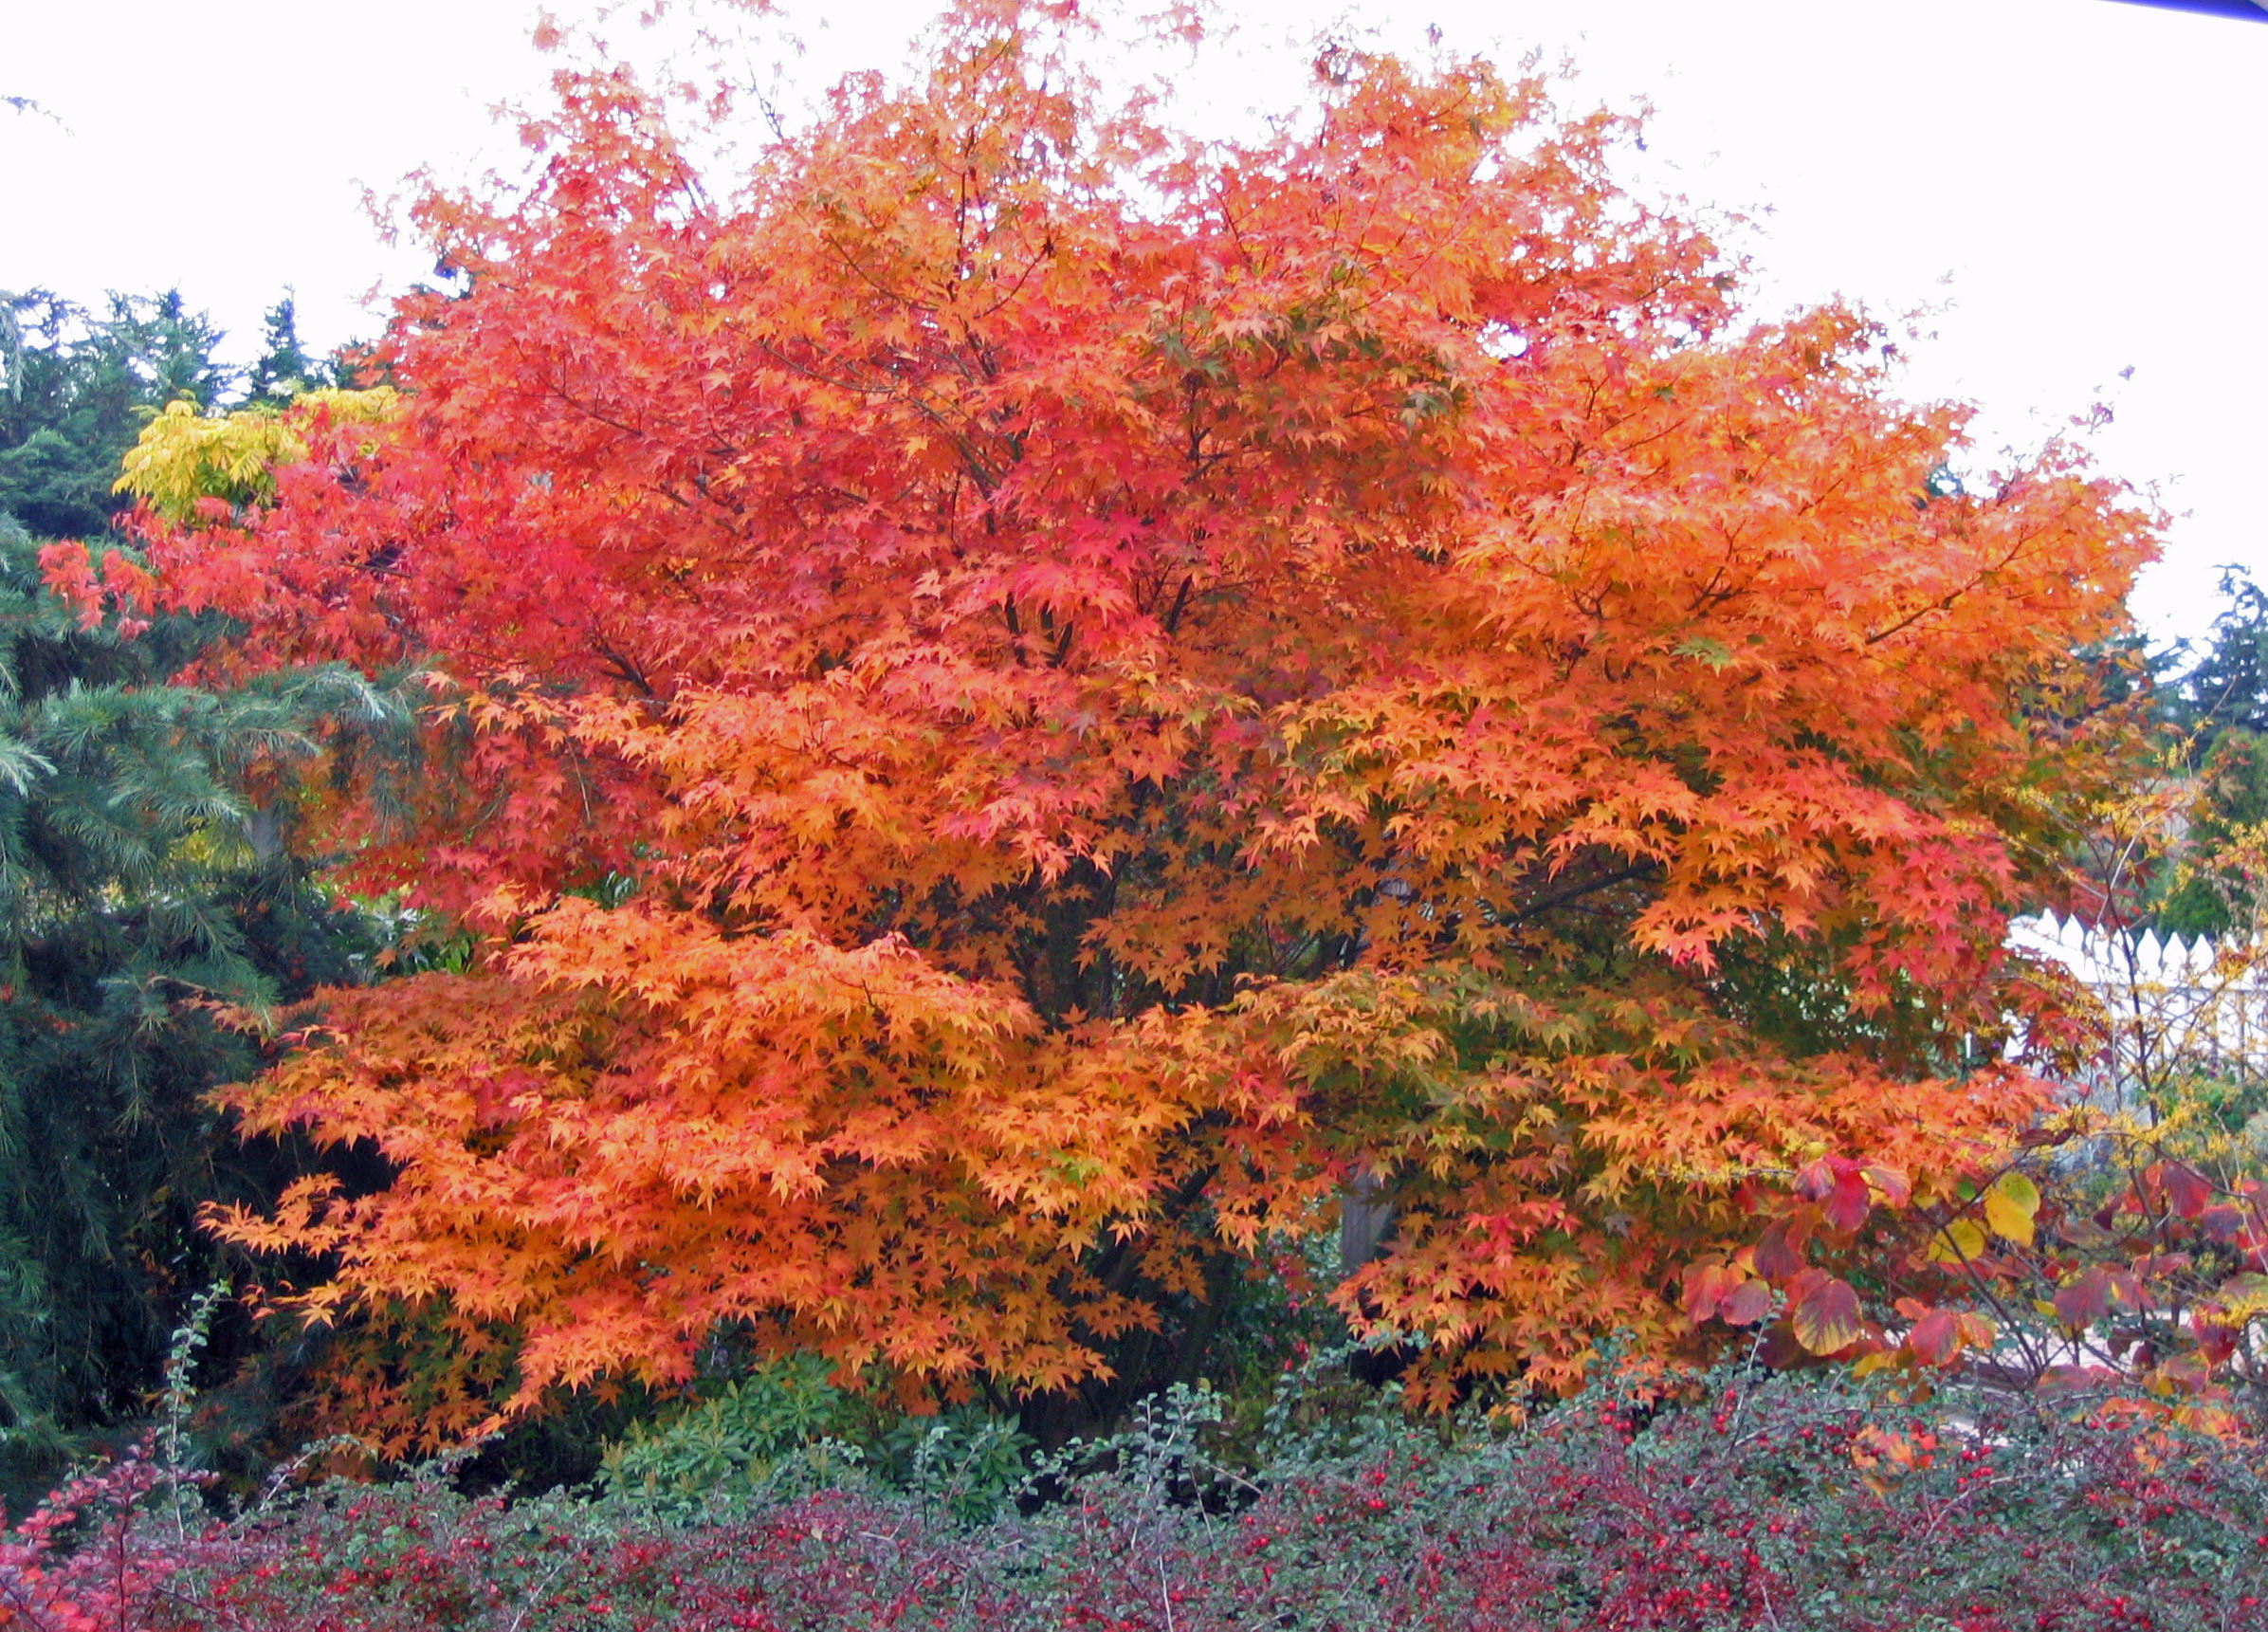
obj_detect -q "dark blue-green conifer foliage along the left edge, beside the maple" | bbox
[0,295,404,1484]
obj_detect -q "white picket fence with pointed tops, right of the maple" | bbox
[2009,912,2268,1096]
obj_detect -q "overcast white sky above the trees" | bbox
[0,0,2268,635]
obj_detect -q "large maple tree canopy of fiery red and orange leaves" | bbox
[106,5,2152,1432]
